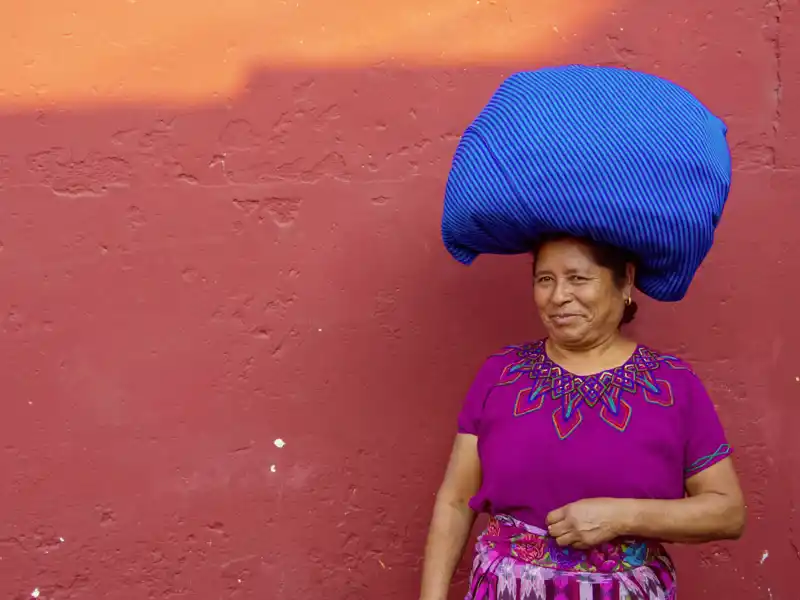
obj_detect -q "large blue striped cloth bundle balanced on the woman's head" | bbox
[442,65,731,301]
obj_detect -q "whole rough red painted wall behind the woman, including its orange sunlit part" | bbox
[0,0,800,600]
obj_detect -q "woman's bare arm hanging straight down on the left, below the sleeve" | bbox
[420,433,481,600]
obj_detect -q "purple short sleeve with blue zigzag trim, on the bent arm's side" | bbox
[684,373,732,479]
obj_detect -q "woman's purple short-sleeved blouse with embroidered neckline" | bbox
[458,340,731,527]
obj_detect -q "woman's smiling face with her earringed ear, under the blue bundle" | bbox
[533,239,633,347]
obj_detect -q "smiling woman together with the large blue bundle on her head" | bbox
[421,67,745,600]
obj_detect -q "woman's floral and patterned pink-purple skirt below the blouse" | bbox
[465,515,677,600]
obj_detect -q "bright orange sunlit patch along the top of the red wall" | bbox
[0,0,613,107]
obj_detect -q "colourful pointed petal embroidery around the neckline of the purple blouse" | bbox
[498,340,687,440]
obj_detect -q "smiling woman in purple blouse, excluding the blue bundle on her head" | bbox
[420,235,745,600]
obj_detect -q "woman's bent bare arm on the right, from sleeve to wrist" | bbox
[616,457,747,544]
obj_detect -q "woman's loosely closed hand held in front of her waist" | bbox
[547,498,628,549]
